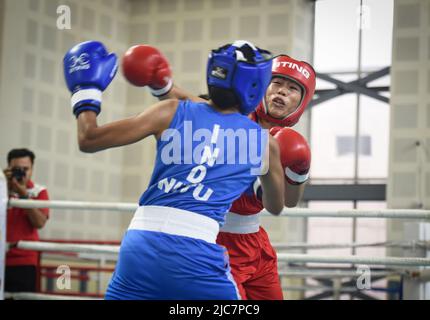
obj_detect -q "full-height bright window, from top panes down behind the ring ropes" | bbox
[305,0,393,299]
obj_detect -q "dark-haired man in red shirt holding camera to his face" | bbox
[4,149,49,292]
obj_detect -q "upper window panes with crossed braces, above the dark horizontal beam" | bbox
[311,0,393,179]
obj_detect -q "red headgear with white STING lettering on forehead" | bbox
[255,55,316,127]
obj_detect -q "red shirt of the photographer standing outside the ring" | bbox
[6,180,49,266]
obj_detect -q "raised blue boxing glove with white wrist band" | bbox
[63,41,118,117]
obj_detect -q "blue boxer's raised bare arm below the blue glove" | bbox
[78,99,178,152]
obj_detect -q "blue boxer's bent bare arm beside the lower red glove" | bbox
[260,136,285,215]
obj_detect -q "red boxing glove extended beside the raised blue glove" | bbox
[122,45,173,97]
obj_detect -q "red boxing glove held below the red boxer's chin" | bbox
[270,127,311,184]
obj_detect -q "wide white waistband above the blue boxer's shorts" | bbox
[128,206,219,243]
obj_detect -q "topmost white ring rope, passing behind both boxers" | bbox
[9,199,430,220]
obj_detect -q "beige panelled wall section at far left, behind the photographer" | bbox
[0,0,128,239]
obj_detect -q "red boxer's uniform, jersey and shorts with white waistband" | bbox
[217,112,283,300]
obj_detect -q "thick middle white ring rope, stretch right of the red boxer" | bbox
[278,253,430,266]
